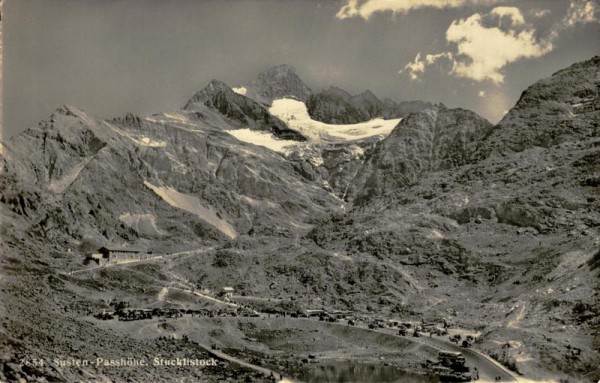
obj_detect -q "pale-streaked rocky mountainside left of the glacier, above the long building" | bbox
[2,100,335,248]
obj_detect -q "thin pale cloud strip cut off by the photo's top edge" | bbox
[335,0,501,20]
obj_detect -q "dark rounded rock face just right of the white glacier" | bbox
[352,105,492,206]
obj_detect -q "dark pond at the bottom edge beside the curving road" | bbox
[298,361,432,383]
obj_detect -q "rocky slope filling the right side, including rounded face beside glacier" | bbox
[309,57,600,381]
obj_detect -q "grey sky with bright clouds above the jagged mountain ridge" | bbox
[2,0,600,138]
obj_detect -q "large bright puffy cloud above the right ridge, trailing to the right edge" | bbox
[400,0,599,84]
